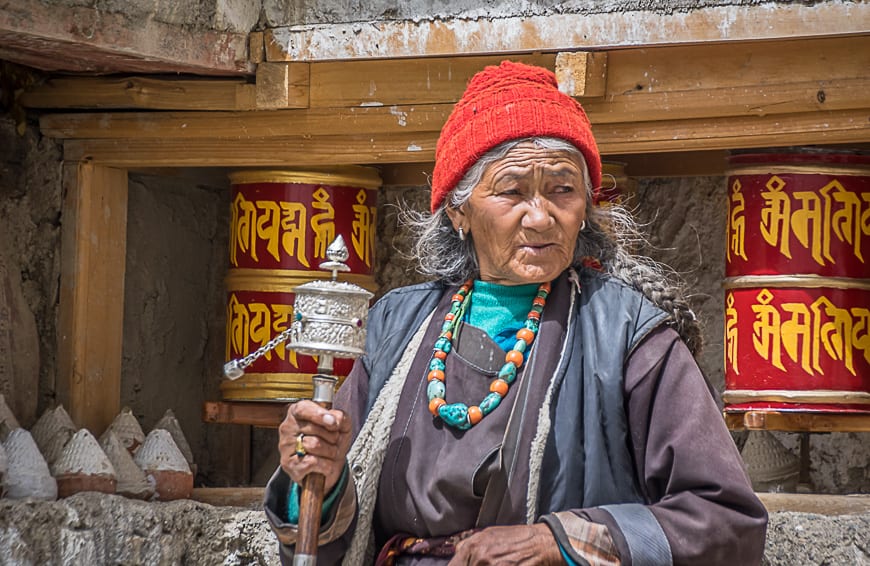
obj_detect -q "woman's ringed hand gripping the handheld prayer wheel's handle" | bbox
[278,401,351,493]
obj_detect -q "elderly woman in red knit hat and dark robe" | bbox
[266,62,767,565]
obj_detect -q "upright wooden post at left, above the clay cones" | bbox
[57,162,127,435]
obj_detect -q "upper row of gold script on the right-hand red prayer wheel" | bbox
[760,175,870,266]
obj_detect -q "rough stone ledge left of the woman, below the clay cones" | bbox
[0,493,278,566]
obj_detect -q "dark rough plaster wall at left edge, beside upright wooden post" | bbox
[0,113,62,427]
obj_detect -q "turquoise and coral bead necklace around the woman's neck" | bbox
[426,279,550,430]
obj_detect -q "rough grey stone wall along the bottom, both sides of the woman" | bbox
[0,493,870,566]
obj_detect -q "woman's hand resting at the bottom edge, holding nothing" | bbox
[449,523,565,566]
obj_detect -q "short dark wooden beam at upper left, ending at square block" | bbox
[19,77,255,111]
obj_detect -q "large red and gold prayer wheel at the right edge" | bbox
[723,148,870,413]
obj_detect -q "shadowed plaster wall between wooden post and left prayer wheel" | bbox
[121,175,245,485]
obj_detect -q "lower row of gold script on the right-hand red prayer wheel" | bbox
[748,289,870,376]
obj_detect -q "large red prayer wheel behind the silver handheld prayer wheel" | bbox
[221,166,381,400]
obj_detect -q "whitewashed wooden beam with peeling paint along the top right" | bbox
[265,0,870,62]
